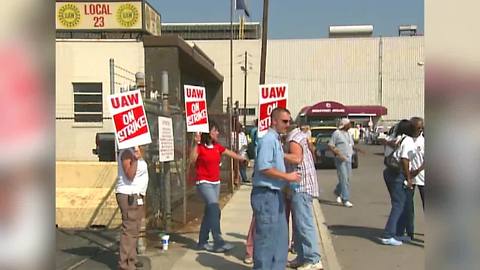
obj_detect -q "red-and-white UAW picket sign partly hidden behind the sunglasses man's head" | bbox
[257,84,288,137]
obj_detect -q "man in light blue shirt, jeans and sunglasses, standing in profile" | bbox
[251,108,300,270]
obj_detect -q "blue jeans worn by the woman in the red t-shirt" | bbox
[197,183,225,247]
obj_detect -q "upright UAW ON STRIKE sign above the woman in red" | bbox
[183,85,209,133]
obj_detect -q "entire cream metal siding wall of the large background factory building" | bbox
[191,36,424,121]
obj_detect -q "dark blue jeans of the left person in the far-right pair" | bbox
[383,169,408,238]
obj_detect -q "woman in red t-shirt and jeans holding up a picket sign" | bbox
[190,122,245,252]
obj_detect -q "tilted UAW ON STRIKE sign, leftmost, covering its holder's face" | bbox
[108,90,152,149]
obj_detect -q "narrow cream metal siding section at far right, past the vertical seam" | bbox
[383,37,425,121]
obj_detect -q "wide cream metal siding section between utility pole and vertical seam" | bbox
[266,38,378,115]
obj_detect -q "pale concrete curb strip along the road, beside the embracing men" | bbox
[313,200,342,270]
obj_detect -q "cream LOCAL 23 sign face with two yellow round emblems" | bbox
[56,1,142,30]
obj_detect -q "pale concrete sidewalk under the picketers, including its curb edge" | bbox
[146,185,340,270]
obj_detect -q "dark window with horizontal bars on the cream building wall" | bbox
[73,83,103,123]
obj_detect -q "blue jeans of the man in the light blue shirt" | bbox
[250,187,288,270]
